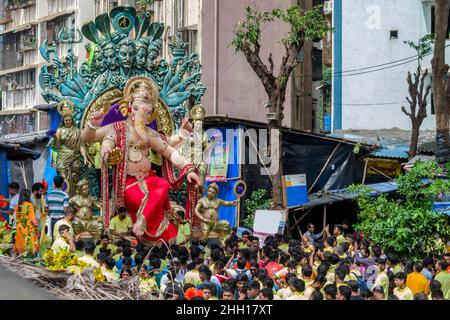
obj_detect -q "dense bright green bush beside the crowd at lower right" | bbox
[348,161,450,258]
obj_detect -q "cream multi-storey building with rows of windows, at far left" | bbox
[0,0,95,138]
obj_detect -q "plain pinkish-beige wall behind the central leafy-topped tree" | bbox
[201,0,292,125]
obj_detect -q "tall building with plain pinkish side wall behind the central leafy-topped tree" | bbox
[152,0,324,131]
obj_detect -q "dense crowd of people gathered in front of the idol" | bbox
[0,177,450,300]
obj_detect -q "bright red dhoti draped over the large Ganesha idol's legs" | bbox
[124,172,177,242]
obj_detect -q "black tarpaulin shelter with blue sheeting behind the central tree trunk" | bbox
[204,116,376,226]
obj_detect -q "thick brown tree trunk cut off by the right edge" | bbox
[431,0,450,165]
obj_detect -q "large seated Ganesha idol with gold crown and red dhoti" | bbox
[82,77,200,244]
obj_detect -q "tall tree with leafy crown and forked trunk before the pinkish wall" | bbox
[231,5,329,209]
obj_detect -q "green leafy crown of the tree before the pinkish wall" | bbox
[231,5,329,53]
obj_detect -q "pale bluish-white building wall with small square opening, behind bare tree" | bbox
[342,0,450,130]
